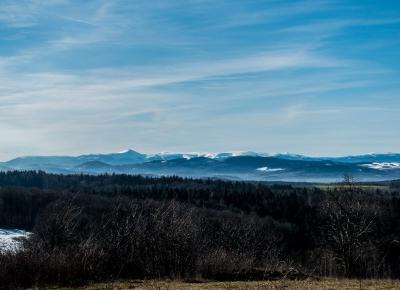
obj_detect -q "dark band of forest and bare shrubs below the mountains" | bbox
[0,171,400,288]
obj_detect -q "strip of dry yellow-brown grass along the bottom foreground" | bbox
[48,279,400,290]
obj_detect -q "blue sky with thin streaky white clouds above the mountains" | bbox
[0,0,400,160]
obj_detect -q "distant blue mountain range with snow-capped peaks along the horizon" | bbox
[0,150,400,182]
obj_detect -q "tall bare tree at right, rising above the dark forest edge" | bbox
[320,179,380,277]
